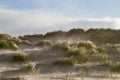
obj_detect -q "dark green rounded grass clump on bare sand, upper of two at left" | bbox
[12,53,30,63]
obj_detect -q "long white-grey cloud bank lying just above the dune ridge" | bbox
[0,9,120,35]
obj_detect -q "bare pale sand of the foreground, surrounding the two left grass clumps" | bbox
[0,47,120,80]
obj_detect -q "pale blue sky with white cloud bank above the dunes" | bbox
[0,0,120,35]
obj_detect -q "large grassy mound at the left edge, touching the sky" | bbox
[0,34,30,50]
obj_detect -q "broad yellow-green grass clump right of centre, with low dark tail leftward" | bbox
[54,48,88,66]
